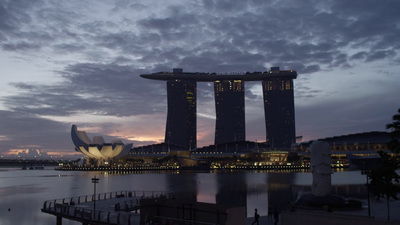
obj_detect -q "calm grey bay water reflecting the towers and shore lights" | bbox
[0,168,366,225]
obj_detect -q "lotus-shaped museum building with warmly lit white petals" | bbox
[71,125,132,164]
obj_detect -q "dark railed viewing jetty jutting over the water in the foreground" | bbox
[42,191,239,225]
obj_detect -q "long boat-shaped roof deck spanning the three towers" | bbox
[140,70,297,82]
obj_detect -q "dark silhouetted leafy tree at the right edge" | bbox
[368,151,400,220]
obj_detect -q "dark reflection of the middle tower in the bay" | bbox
[215,173,247,206]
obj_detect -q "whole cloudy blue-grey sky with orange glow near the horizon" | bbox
[0,0,400,155]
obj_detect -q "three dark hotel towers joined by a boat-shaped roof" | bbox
[140,67,297,149]
